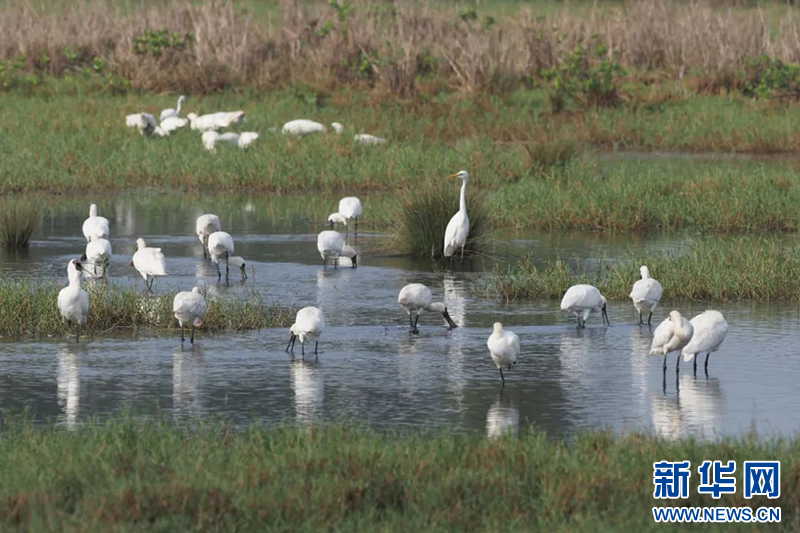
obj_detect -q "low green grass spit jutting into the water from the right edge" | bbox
[482,237,800,302]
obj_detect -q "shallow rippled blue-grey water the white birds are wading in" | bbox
[0,191,800,438]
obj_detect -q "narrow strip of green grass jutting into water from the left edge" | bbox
[0,280,294,338]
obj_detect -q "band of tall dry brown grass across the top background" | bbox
[0,0,800,94]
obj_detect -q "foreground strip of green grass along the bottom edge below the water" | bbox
[0,417,800,532]
